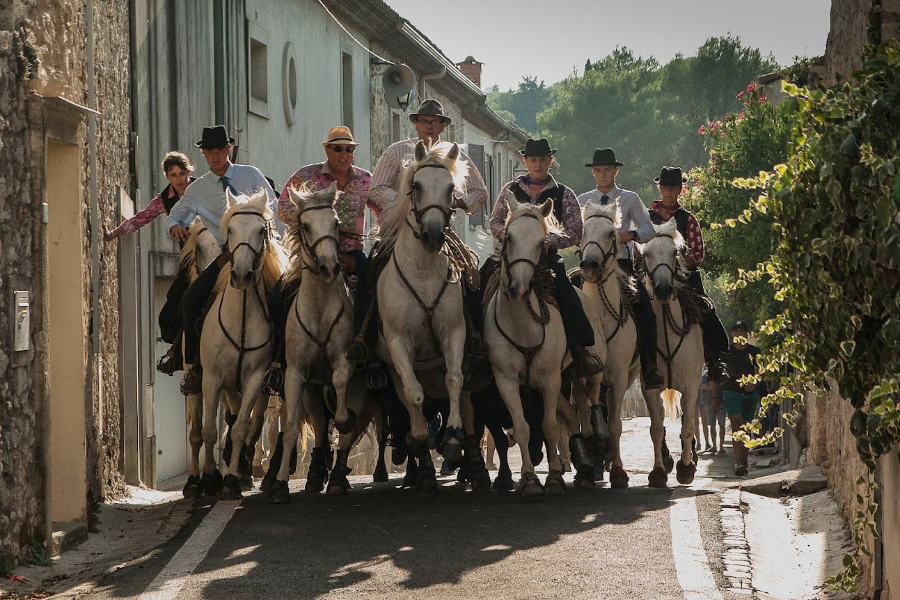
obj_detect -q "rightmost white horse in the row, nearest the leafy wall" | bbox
[641,219,704,487]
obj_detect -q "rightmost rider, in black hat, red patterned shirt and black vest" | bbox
[650,167,728,382]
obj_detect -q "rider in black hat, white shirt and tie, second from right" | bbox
[578,148,664,389]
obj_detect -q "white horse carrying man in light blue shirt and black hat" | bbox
[200,192,287,498]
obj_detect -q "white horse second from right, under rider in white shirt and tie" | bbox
[580,202,640,488]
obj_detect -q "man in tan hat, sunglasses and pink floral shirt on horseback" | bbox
[269,125,381,391]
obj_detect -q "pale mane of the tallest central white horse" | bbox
[379,142,469,252]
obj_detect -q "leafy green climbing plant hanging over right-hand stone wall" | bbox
[740,40,900,587]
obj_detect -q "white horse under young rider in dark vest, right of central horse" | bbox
[484,194,571,498]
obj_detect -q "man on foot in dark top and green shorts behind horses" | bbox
[724,321,759,477]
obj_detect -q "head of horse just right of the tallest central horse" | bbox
[500,192,553,302]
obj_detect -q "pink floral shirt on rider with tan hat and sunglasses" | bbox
[278,162,381,252]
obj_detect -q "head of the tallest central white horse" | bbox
[404,140,465,252]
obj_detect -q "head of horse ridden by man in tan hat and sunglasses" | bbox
[288,183,341,281]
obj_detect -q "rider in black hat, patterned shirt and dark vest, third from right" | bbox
[490,139,603,377]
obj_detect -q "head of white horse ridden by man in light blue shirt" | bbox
[221,191,273,289]
